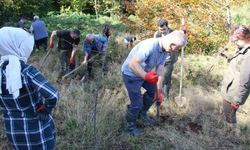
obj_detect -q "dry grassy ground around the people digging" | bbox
[0,9,250,150]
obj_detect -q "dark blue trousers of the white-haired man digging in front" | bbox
[122,74,156,115]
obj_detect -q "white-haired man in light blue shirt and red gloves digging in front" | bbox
[121,31,186,136]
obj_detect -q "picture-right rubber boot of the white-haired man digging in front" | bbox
[140,93,157,126]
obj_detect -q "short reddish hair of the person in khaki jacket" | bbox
[231,25,250,40]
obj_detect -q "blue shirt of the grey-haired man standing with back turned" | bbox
[31,20,48,40]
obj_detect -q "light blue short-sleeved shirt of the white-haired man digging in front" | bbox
[122,38,168,77]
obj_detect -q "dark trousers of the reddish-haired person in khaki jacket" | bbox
[223,100,237,123]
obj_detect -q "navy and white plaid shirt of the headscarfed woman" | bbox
[0,61,58,150]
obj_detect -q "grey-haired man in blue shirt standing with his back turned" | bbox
[30,16,48,50]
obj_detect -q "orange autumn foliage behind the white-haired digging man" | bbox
[135,0,245,53]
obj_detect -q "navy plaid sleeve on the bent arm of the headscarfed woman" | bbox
[28,67,59,109]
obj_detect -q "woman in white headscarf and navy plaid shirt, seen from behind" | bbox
[0,27,58,150]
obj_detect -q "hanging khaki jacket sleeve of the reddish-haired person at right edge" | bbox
[237,52,250,105]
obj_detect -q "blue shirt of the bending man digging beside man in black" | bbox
[83,35,108,54]
